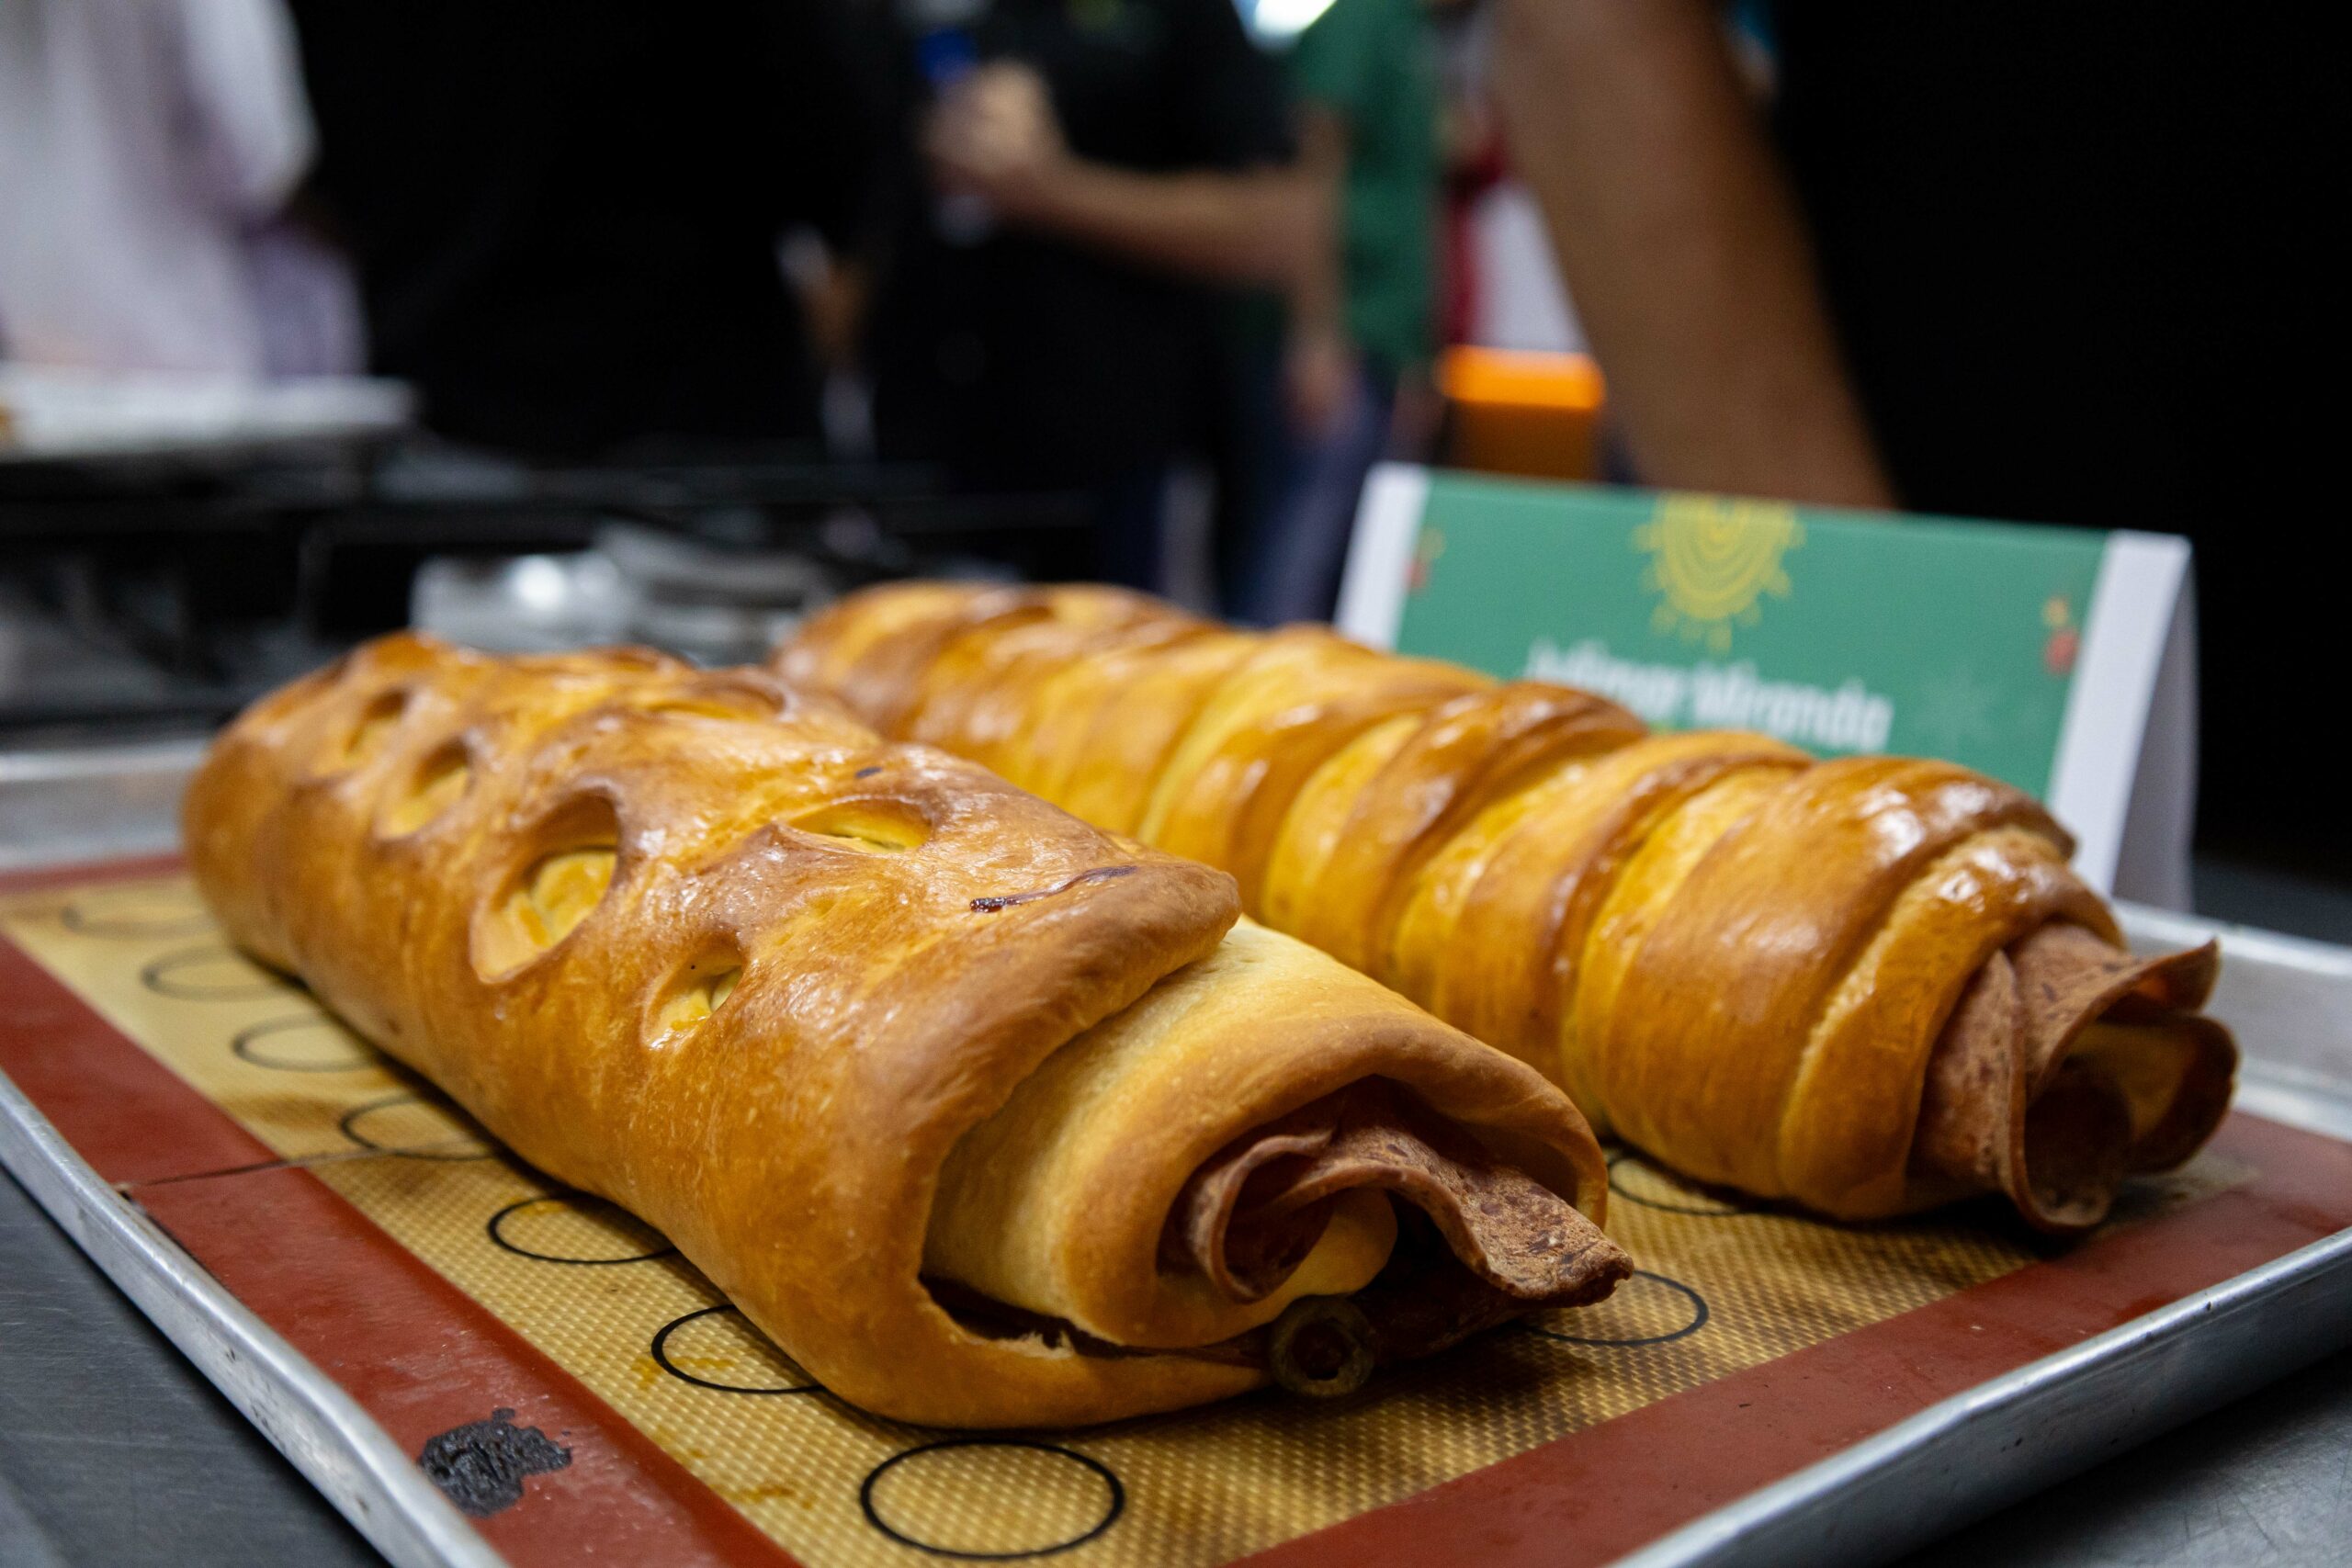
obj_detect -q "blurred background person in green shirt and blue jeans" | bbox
[1226,0,1440,626]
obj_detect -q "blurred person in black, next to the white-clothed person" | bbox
[294,0,875,458]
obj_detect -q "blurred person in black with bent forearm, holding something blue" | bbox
[868,0,1312,588]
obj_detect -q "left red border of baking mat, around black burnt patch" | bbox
[0,858,795,1568]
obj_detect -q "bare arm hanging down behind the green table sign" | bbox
[1496,0,1894,505]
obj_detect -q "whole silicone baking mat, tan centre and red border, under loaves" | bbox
[0,865,2352,1568]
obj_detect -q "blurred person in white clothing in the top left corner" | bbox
[0,0,360,376]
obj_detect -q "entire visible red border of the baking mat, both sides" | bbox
[0,856,2352,1568]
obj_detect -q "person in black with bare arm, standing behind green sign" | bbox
[1496,0,2352,872]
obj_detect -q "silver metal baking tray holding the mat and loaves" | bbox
[0,745,2352,1568]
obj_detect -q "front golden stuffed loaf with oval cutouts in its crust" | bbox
[186,637,1630,1427]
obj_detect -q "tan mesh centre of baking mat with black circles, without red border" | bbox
[0,877,2244,1568]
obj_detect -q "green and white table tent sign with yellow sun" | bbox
[1339,466,2194,905]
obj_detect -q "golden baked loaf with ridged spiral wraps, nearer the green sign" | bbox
[776,583,2237,1232]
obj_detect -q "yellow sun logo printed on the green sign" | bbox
[1633,496,1804,653]
